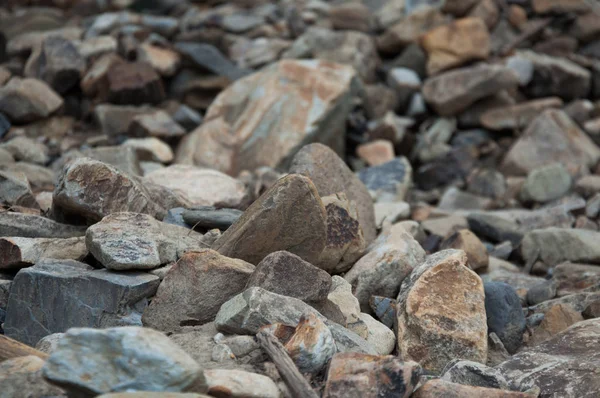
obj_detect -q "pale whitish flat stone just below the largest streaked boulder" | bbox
[144,164,246,208]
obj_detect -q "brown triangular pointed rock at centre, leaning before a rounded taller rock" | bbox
[212,174,327,264]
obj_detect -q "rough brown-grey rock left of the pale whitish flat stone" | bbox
[52,158,166,221]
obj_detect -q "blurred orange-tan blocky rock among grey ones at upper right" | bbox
[421,18,490,75]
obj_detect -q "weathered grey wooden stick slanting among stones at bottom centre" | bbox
[256,330,319,398]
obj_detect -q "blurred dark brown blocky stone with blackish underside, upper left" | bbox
[106,62,165,105]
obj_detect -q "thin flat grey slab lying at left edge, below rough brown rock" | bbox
[0,211,86,238]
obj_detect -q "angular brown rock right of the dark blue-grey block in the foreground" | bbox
[142,249,254,331]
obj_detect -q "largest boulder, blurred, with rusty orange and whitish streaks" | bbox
[176,60,358,176]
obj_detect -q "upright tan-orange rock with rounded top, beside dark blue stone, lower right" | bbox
[397,249,488,373]
